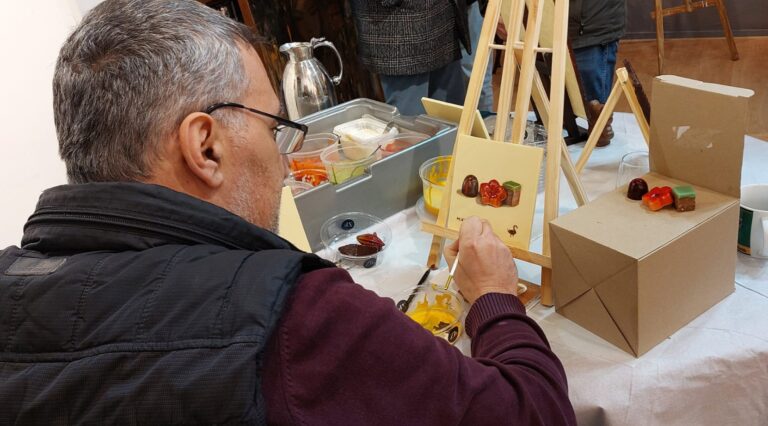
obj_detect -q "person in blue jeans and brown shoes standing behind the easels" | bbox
[568,0,626,146]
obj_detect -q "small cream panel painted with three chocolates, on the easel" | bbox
[440,135,543,249]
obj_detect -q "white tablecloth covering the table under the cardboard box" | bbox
[330,113,768,425]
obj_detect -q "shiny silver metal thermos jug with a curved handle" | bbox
[280,38,344,120]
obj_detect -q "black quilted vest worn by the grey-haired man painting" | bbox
[0,183,329,425]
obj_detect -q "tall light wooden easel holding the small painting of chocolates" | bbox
[422,0,586,306]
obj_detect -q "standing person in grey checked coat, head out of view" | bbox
[350,0,474,115]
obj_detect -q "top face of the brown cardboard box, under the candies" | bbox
[551,173,739,260]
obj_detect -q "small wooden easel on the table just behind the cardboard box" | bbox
[576,61,651,173]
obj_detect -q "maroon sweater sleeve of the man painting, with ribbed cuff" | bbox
[263,269,576,425]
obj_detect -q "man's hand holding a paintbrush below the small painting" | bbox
[445,216,517,303]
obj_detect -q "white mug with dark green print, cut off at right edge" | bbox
[739,184,768,259]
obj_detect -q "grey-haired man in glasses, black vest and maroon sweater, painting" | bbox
[0,0,574,425]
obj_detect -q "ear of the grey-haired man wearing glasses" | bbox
[179,112,224,188]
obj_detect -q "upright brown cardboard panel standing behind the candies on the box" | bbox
[650,75,754,197]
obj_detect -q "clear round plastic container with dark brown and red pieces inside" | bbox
[320,212,392,268]
